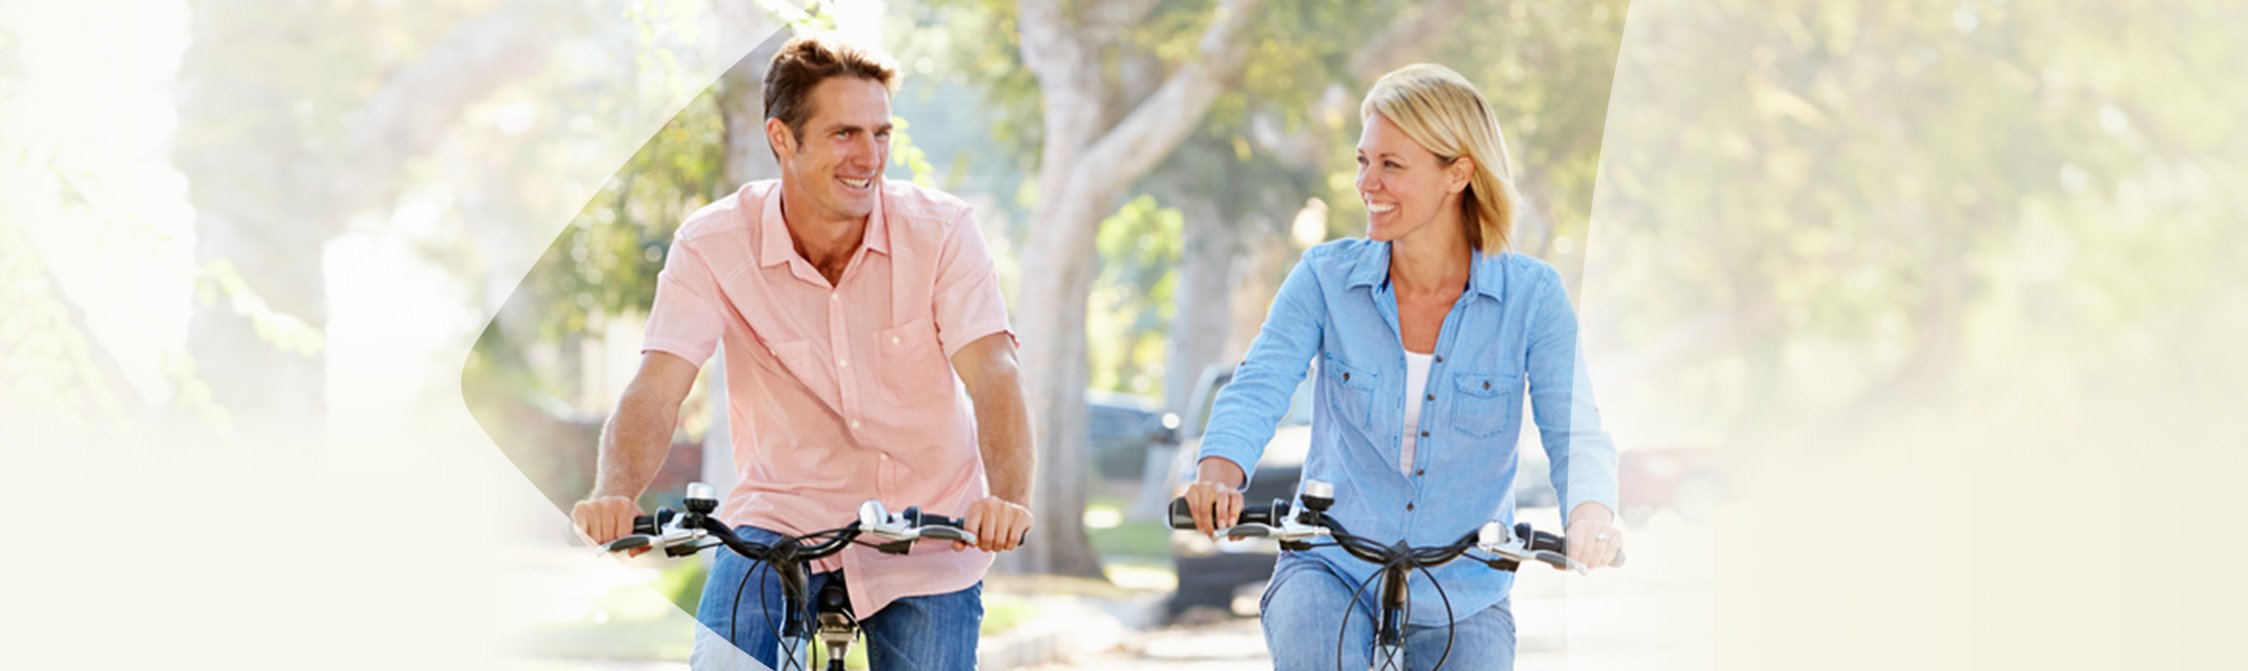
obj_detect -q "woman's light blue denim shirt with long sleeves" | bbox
[1198,239,1616,624]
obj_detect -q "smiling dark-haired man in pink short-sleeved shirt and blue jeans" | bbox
[571,36,1032,669]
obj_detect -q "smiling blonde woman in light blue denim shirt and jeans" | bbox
[1185,65,1623,669]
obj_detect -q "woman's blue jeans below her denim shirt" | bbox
[1263,552,1515,671]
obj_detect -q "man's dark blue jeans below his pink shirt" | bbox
[690,527,982,671]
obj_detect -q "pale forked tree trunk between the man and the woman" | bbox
[1005,0,1263,576]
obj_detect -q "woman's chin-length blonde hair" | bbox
[1358,63,1515,254]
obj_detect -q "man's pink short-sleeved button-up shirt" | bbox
[641,180,1014,617]
